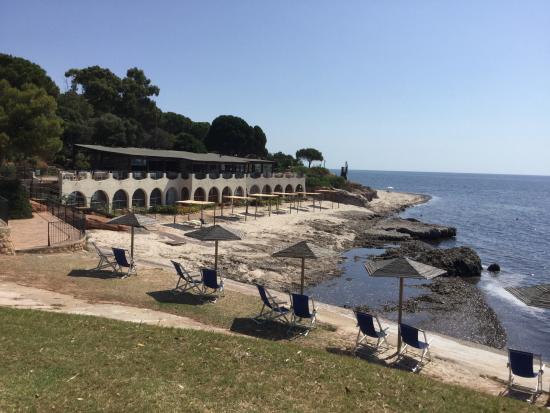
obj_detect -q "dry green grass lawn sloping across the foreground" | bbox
[0,309,532,412]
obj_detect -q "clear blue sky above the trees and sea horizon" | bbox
[0,0,550,175]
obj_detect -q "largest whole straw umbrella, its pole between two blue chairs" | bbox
[365,258,447,352]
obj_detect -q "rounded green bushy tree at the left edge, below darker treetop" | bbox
[0,79,63,161]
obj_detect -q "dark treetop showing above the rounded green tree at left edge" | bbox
[0,53,59,97]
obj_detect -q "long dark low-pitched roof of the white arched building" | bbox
[76,144,273,163]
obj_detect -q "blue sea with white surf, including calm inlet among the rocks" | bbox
[309,170,550,360]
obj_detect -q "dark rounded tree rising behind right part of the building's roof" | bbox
[204,115,267,156]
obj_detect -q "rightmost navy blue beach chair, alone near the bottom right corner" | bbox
[507,349,545,402]
